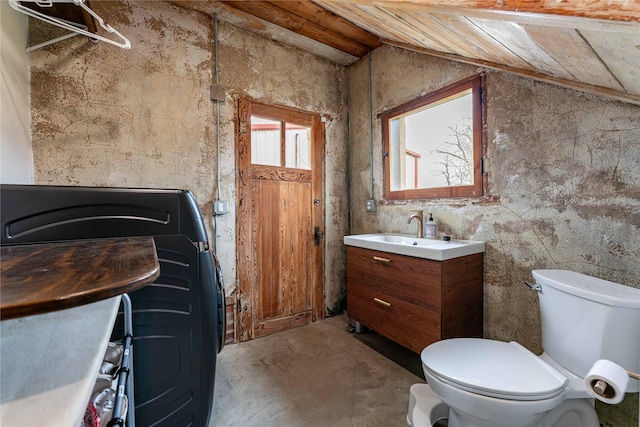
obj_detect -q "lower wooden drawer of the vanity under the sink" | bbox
[347,283,440,353]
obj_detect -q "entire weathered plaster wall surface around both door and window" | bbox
[29,1,640,426]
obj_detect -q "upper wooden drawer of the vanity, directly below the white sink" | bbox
[347,246,442,310]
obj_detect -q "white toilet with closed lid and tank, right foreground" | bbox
[407,270,640,427]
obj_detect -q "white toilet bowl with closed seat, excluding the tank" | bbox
[421,338,599,427]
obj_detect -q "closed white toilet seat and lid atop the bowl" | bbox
[421,338,568,401]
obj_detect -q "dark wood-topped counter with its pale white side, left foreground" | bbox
[0,237,159,427]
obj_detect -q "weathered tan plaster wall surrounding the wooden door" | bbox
[30,1,348,311]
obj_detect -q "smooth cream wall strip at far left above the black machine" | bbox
[0,0,33,184]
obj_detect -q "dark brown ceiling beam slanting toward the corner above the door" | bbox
[220,0,371,58]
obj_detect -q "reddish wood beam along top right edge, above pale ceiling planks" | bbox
[330,0,640,22]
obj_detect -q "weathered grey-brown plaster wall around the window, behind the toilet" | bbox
[349,47,640,426]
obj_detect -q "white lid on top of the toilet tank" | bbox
[532,270,640,310]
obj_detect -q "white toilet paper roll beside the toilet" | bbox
[584,359,629,405]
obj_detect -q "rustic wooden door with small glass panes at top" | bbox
[237,99,324,341]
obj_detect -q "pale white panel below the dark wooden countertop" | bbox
[0,296,121,427]
